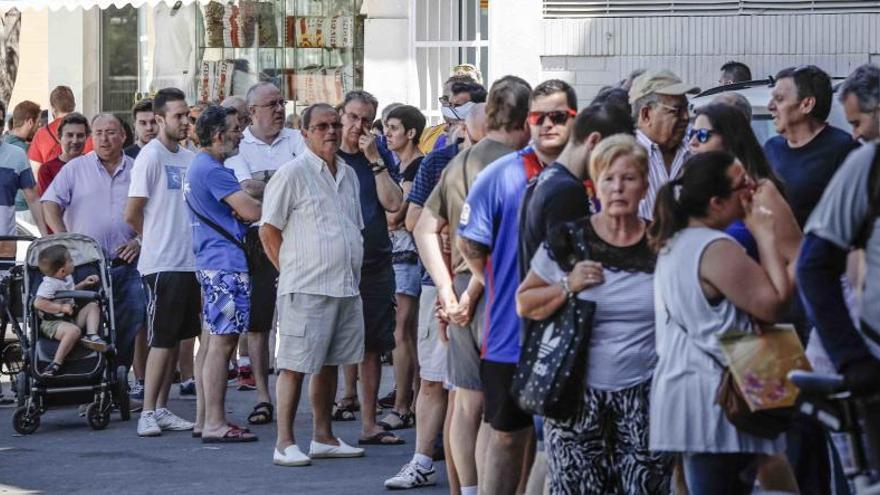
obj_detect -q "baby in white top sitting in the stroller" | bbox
[34,245,107,376]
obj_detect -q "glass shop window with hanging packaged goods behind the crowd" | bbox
[196,0,363,107]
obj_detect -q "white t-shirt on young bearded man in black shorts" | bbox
[128,139,196,275]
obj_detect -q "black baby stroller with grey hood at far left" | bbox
[12,233,131,435]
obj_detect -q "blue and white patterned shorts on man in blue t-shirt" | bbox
[196,270,251,335]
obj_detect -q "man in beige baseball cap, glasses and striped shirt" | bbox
[629,69,700,220]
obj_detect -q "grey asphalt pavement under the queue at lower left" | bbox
[0,366,449,495]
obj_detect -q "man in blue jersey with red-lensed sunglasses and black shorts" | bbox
[458,80,577,494]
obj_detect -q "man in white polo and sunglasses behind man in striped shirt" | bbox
[226,82,305,424]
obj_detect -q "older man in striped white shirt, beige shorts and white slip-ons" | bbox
[260,103,364,466]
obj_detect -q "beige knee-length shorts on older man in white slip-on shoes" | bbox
[276,294,364,373]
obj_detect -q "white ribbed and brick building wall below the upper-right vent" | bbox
[540,14,880,103]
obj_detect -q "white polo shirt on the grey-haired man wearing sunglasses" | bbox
[225,127,306,182]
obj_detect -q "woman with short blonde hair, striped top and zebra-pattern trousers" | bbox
[516,134,671,494]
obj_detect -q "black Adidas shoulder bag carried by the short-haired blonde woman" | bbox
[511,222,596,419]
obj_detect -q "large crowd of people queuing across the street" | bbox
[0,57,880,495]
